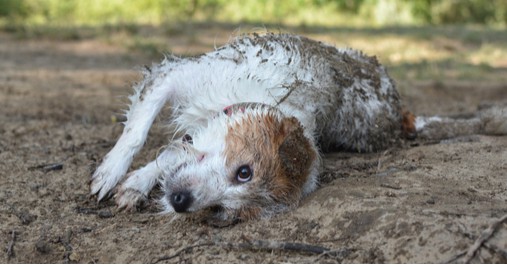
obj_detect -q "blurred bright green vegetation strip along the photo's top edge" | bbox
[0,0,507,26]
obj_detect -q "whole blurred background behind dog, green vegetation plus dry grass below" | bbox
[0,0,507,82]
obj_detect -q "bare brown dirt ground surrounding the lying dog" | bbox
[0,30,507,263]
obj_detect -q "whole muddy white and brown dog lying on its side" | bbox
[90,33,507,221]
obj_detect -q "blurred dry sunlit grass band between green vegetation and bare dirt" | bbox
[4,22,507,82]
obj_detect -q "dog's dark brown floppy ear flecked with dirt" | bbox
[278,117,317,187]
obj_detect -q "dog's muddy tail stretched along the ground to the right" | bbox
[403,105,507,140]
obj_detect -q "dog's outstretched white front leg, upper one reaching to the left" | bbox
[90,73,177,201]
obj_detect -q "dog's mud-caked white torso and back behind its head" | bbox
[161,34,401,151]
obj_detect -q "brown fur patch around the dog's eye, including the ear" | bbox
[224,112,317,219]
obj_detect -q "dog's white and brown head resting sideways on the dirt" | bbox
[162,103,318,220]
